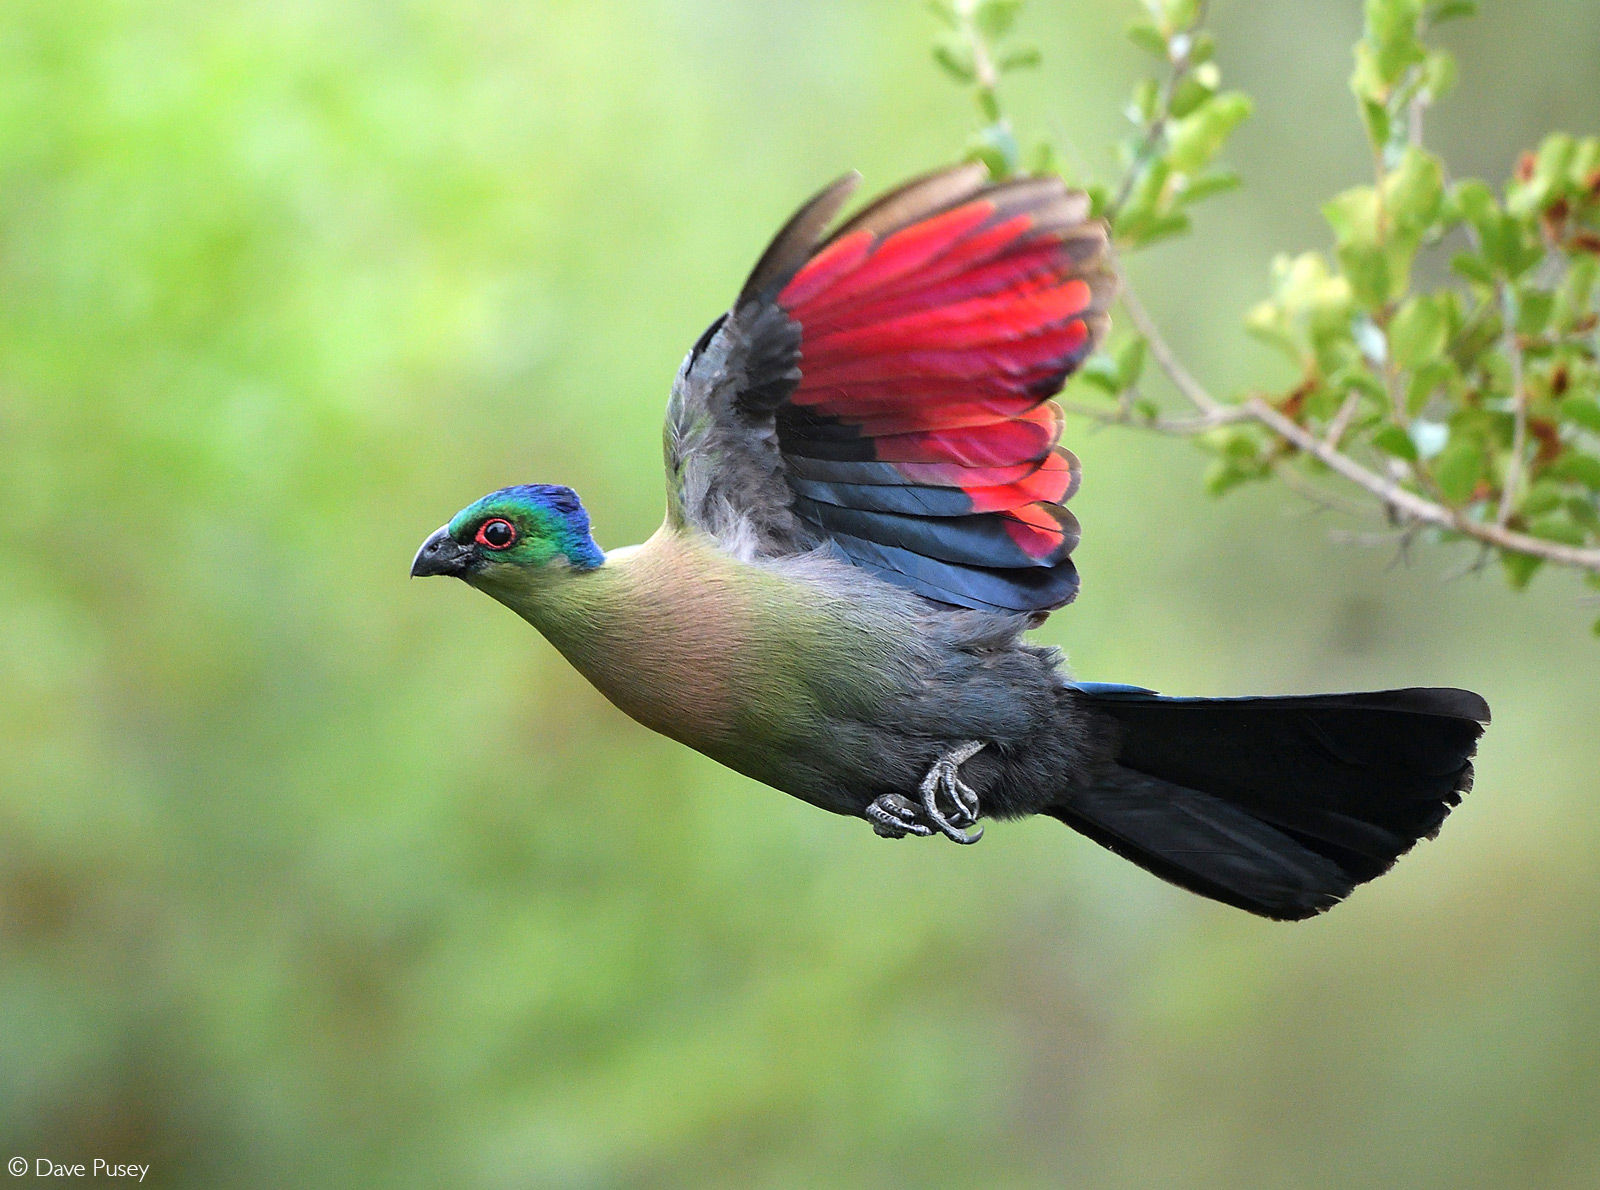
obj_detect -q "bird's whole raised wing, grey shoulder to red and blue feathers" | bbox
[667,165,1112,611]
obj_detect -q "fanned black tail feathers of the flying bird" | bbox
[1048,685,1490,921]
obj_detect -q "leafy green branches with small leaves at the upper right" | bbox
[931,0,1600,617]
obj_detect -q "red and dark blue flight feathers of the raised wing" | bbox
[764,166,1112,611]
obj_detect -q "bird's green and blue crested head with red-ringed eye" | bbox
[411,483,605,587]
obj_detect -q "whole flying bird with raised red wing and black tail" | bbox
[411,165,1490,920]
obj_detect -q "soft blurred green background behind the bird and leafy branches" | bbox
[0,0,1600,1190]
